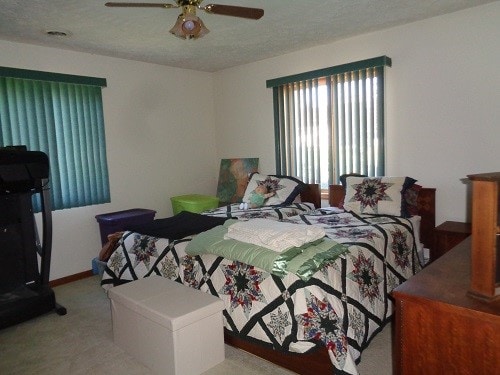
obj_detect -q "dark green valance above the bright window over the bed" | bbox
[266,56,392,88]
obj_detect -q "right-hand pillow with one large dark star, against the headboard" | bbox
[344,177,416,216]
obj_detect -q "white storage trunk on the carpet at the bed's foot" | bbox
[108,276,225,375]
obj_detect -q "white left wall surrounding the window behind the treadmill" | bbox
[0,41,218,280]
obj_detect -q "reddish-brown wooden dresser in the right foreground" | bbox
[393,237,500,375]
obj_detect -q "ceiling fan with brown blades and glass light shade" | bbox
[105,0,264,39]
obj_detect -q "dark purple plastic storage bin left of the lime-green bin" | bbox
[95,208,156,246]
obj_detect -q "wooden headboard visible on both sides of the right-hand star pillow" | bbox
[328,185,436,253]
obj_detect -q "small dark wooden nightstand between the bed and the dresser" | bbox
[430,221,472,262]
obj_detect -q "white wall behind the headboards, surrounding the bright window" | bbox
[215,2,500,224]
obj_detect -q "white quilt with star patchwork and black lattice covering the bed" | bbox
[102,204,420,374]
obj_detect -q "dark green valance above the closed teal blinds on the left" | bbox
[0,66,106,87]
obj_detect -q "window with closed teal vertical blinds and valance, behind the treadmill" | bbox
[0,67,110,209]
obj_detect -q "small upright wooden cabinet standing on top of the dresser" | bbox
[467,172,500,300]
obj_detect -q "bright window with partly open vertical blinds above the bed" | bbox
[267,56,391,190]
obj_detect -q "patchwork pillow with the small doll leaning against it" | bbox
[243,173,306,206]
